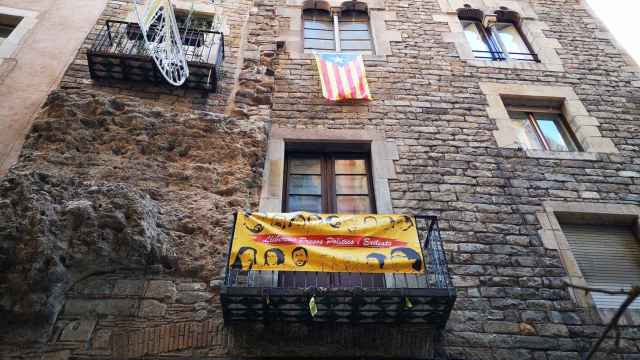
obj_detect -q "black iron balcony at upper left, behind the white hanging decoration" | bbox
[87,20,224,92]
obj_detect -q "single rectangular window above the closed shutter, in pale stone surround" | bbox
[507,107,582,152]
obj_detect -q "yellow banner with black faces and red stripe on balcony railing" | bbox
[229,212,424,273]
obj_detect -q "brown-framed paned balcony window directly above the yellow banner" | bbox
[284,152,375,213]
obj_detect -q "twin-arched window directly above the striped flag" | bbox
[302,2,373,54]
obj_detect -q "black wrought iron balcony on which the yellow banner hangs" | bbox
[220,216,456,328]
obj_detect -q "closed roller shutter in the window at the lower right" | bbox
[562,224,640,309]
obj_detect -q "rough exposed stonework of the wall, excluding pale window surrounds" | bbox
[0,0,640,360]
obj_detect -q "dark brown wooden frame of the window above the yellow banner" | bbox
[282,151,377,214]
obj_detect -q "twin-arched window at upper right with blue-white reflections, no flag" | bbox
[460,17,538,62]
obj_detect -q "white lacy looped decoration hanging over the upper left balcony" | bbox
[134,0,189,86]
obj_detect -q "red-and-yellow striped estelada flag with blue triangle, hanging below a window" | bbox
[316,53,371,101]
